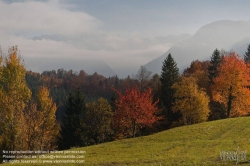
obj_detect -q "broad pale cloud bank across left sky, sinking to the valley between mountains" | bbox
[0,0,185,76]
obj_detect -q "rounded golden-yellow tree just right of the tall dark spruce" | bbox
[172,76,210,125]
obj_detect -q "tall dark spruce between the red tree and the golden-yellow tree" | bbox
[160,54,180,127]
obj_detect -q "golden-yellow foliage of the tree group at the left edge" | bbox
[0,47,59,150]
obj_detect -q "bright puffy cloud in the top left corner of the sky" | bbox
[0,0,101,35]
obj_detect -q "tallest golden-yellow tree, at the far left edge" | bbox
[0,46,31,150]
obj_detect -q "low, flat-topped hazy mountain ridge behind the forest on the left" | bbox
[24,57,116,77]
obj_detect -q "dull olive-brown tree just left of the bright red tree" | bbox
[84,98,113,144]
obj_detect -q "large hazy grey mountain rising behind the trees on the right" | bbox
[144,20,250,74]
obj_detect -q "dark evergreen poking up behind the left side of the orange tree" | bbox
[208,48,222,85]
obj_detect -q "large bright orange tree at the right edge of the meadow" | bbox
[211,53,250,117]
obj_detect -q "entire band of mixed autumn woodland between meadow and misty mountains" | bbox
[0,45,250,158]
